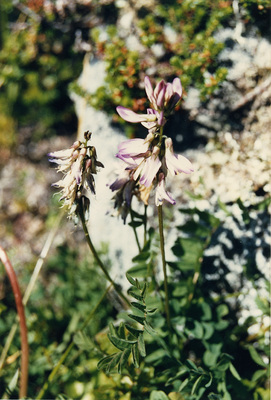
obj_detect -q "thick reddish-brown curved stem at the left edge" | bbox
[0,246,29,399]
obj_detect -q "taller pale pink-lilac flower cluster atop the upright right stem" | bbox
[110,76,193,221]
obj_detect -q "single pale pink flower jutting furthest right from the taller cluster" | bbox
[165,138,194,175]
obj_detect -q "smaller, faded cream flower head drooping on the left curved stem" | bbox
[48,131,103,216]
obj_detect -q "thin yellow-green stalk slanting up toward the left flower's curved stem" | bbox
[36,286,110,400]
